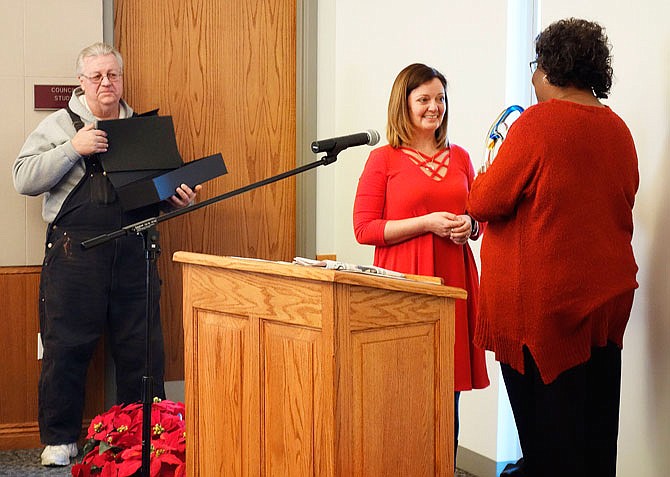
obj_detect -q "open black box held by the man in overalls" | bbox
[97,115,228,210]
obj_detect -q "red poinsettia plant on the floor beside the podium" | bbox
[72,398,186,477]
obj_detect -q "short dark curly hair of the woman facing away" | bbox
[535,18,613,98]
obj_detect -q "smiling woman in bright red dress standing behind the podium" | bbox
[354,64,489,455]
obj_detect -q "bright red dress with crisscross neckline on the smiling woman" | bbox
[354,144,489,391]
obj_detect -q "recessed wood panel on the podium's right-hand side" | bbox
[351,324,441,477]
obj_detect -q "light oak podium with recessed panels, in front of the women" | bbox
[174,252,466,477]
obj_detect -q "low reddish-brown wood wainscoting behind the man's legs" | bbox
[0,267,105,449]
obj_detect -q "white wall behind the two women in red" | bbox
[317,0,670,477]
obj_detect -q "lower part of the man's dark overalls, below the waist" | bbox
[38,226,165,445]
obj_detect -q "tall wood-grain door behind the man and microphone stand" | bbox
[114,0,296,380]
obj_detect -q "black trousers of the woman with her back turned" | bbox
[501,343,621,477]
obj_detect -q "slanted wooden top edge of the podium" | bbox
[173,251,467,299]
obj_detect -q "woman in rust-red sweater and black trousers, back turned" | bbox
[468,19,638,477]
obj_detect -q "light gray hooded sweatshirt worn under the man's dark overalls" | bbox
[12,88,133,223]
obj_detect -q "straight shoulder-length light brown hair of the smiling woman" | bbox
[386,63,449,147]
